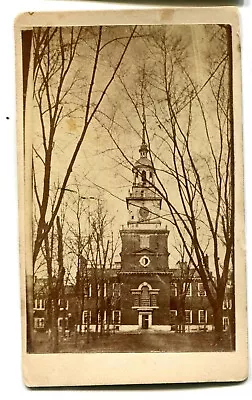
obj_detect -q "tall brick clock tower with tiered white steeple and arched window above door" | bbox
[120,129,171,330]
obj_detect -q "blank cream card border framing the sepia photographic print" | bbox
[15,7,248,387]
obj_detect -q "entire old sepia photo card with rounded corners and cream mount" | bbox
[15,7,247,386]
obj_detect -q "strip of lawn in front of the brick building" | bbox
[34,331,232,353]
